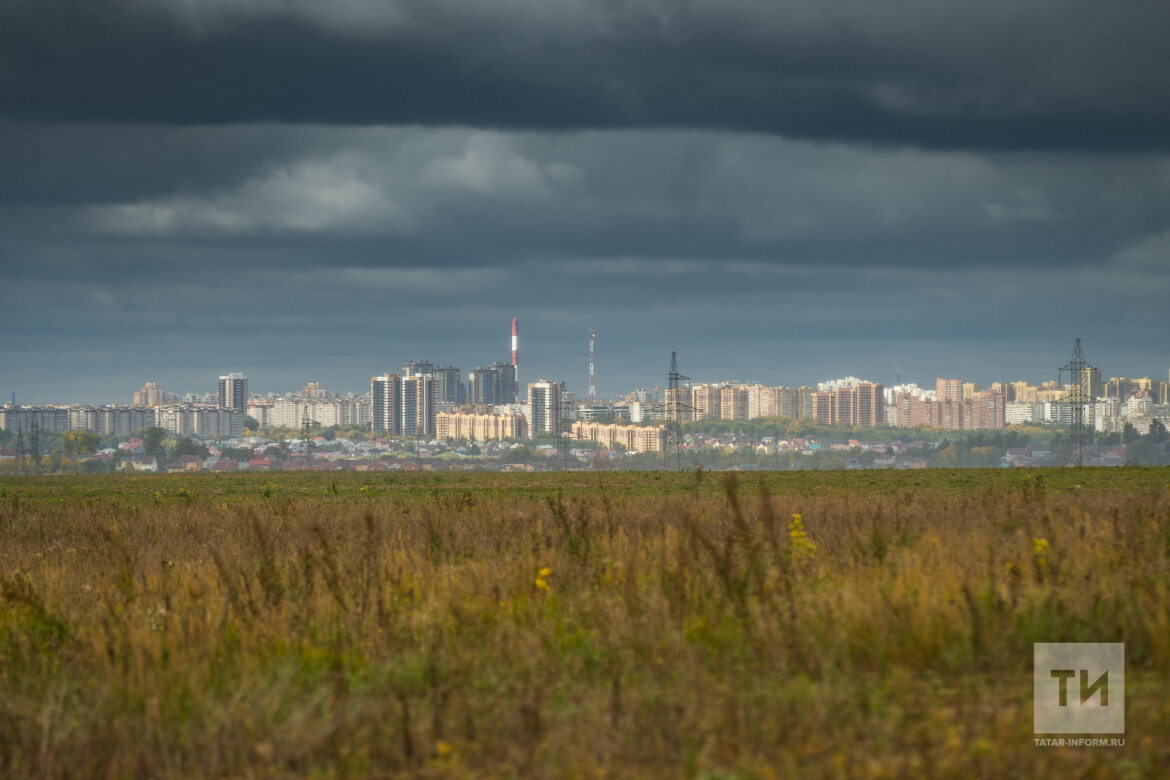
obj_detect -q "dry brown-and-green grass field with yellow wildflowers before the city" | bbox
[0,469,1170,778]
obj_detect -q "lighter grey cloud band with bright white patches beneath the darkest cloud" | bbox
[9,125,1170,268]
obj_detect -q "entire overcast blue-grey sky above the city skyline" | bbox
[0,0,1170,403]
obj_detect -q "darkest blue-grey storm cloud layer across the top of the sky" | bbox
[0,0,1170,150]
